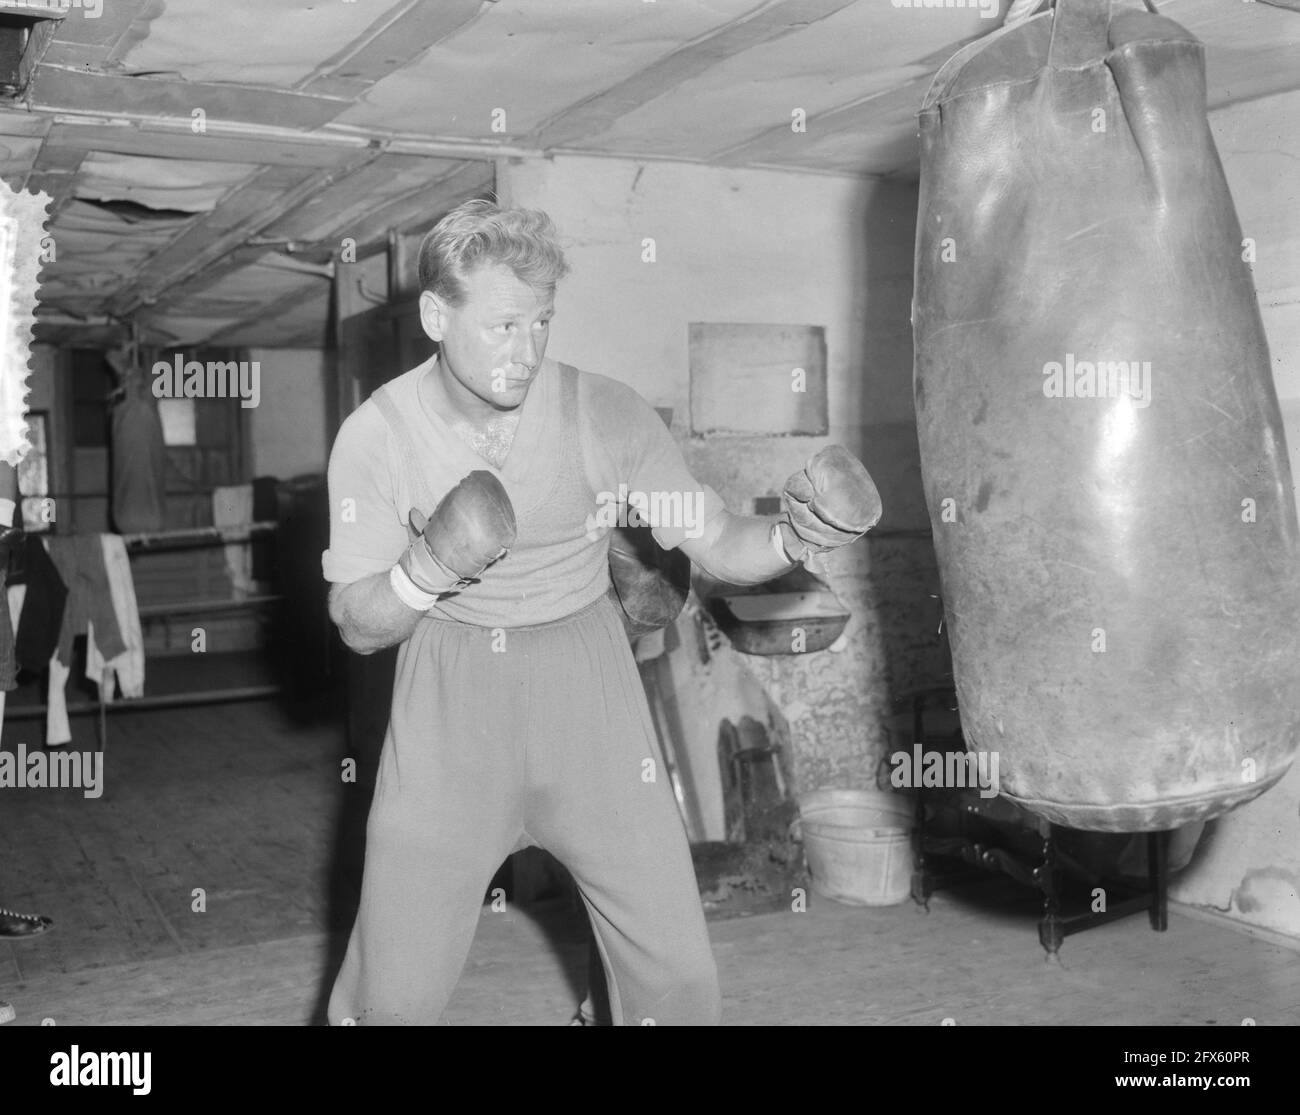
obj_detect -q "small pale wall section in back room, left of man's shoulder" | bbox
[248,348,333,480]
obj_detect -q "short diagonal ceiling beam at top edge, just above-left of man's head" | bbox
[294,0,490,100]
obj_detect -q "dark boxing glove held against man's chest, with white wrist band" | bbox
[390,469,516,611]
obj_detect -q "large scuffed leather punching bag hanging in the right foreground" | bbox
[913,0,1300,832]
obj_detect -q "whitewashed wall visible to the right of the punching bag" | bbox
[1170,94,1300,937]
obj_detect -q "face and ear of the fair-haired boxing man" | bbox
[420,264,555,411]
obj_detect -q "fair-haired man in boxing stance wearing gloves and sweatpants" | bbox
[324,200,880,1024]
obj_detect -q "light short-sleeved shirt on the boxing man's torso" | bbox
[315,357,723,626]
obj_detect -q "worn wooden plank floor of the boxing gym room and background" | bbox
[0,702,1300,1025]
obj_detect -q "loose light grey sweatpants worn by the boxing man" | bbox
[321,595,720,1025]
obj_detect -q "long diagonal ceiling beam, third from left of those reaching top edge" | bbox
[525,0,857,151]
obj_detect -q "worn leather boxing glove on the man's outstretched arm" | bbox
[777,446,883,561]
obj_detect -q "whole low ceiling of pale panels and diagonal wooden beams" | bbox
[0,0,1300,347]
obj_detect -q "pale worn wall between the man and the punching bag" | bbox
[498,157,948,790]
